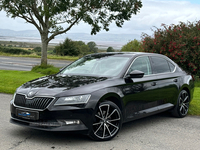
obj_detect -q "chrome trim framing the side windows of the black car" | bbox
[123,55,177,78]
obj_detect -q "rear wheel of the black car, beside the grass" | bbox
[172,90,190,118]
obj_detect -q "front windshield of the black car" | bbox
[61,55,129,77]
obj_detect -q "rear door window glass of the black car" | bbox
[151,56,171,74]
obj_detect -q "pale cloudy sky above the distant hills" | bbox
[0,0,200,35]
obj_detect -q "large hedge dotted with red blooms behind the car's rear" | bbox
[142,21,200,76]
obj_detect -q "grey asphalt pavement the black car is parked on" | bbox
[0,94,200,150]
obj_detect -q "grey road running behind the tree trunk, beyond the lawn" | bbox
[0,56,71,71]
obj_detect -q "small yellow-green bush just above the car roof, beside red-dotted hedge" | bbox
[121,39,142,52]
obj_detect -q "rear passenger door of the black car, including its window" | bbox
[150,56,179,106]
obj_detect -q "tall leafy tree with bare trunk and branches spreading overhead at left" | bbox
[0,0,142,65]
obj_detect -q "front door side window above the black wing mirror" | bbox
[128,56,152,75]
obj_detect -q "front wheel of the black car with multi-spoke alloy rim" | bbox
[89,101,122,141]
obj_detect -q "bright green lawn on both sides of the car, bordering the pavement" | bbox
[0,70,200,116]
